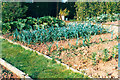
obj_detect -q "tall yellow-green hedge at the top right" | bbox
[75,0,120,21]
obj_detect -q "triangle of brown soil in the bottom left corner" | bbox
[0,65,20,80]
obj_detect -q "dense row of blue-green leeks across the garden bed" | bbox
[13,23,110,45]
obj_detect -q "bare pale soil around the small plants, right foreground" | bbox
[56,41,118,78]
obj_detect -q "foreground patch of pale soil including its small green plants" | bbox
[1,35,118,78]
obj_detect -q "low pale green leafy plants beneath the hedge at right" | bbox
[87,13,120,23]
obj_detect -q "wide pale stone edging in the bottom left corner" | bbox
[0,58,33,80]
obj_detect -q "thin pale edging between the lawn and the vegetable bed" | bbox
[0,36,92,78]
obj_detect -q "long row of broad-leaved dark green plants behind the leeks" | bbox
[2,16,65,33]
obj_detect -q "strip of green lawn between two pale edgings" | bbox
[0,39,88,78]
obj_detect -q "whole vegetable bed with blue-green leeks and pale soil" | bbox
[3,15,119,78]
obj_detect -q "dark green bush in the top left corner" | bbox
[2,2,28,22]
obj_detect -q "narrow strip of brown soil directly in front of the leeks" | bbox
[3,33,116,53]
